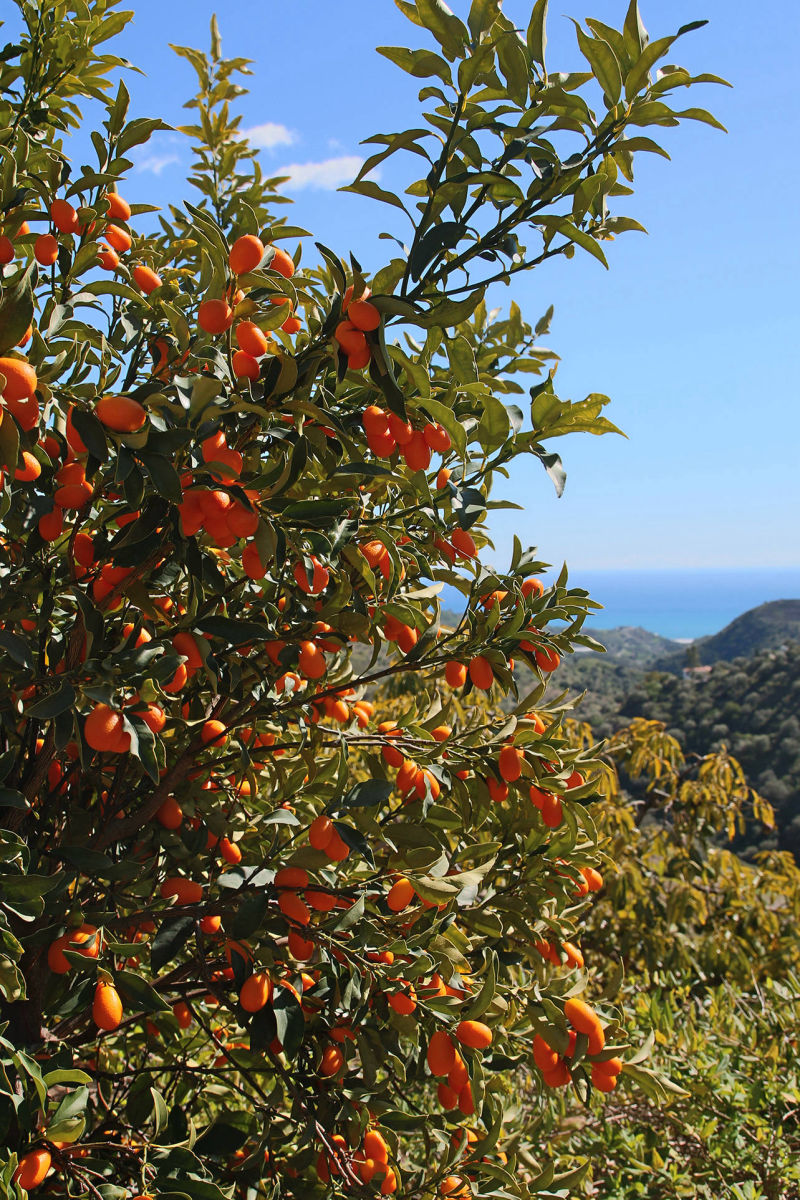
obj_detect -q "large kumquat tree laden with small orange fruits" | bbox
[0,0,762,1200]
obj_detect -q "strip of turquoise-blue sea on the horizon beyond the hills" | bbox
[443,566,800,638]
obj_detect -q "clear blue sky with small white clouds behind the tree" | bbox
[21,0,800,568]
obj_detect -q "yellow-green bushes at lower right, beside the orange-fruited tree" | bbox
[546,719,800,1200]
